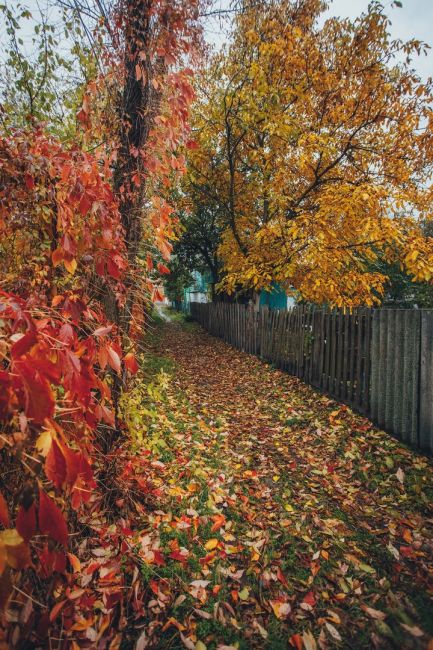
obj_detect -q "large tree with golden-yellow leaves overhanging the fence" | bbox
[189,0,433,306]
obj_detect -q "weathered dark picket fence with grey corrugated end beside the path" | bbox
[191,302,433,452]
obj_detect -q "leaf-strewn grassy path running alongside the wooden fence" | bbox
[129,312,433,650]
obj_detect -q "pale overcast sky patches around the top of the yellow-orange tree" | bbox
[206,0,433,79]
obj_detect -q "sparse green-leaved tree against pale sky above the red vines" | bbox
[0,3,99,139]
